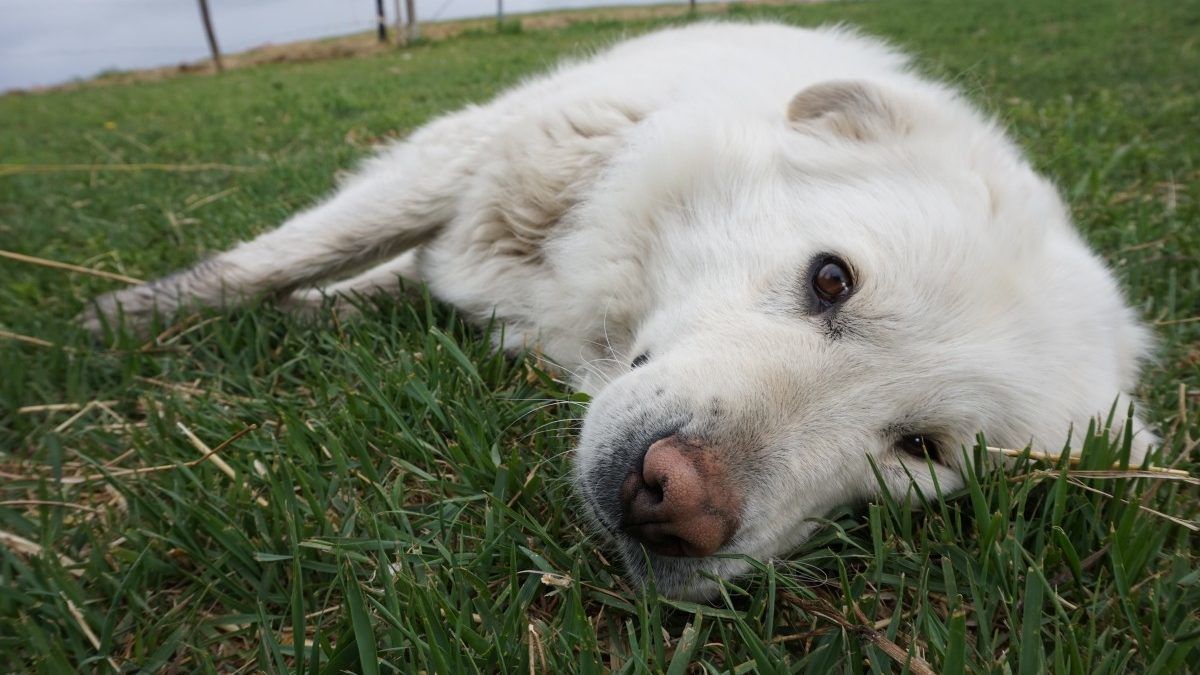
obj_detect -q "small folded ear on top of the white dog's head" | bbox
[787,79,912,141]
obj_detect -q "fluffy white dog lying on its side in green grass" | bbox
[84,24,1152,597]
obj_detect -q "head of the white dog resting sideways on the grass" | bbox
[564,76,1150,597]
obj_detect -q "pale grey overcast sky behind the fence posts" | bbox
[0,0,676,91]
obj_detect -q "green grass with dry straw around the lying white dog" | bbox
[0,0,1200,674]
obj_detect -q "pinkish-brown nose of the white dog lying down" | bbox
[620,436,742,557]
